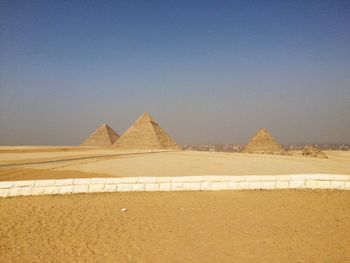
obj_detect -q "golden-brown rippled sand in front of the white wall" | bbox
[0,190,350,263]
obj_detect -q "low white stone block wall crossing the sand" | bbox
[0,174,350,197]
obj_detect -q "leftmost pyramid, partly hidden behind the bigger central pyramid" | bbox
[80,124,119,147]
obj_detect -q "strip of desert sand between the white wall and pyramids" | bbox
[0,147,350,180]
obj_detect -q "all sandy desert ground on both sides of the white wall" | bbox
[0,147,350,262]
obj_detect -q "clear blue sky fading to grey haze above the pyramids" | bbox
[0,0,350,145]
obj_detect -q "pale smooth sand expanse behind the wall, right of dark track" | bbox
[52,152,350,176]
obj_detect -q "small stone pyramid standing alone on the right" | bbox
[242,129,287,154]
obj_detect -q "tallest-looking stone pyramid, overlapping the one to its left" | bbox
[113,112,180,151]
